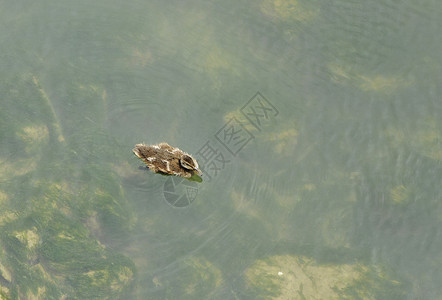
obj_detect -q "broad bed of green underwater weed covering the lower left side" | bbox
[0,74,136,299]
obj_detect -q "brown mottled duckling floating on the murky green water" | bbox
[132,143,202,178]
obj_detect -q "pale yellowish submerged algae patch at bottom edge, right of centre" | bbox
[245,255,405,299]
